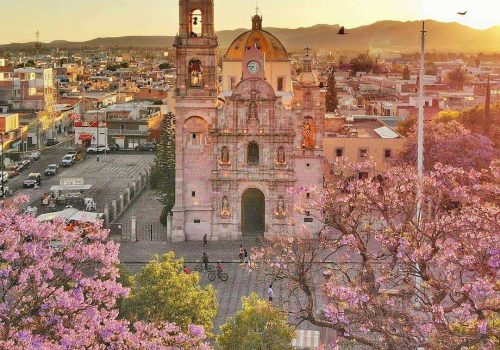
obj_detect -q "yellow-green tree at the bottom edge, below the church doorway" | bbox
[217,293,295,350]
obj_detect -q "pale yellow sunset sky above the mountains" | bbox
[0,0,500,43]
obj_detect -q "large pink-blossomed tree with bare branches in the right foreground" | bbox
[252,159,500,349]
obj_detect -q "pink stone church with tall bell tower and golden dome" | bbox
[172,0,325,241]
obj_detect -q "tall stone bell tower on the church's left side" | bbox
[172,0,218,242]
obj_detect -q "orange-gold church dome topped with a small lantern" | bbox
[226,15,288,61]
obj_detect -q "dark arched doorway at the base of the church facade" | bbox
[241,188,266,236]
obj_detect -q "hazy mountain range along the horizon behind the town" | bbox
[0,20,500,52]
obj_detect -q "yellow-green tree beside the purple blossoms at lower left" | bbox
[121,252,217,331]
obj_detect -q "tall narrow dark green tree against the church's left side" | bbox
[155,112,175,216]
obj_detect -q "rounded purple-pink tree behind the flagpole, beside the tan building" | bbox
[396,117,499,170]
